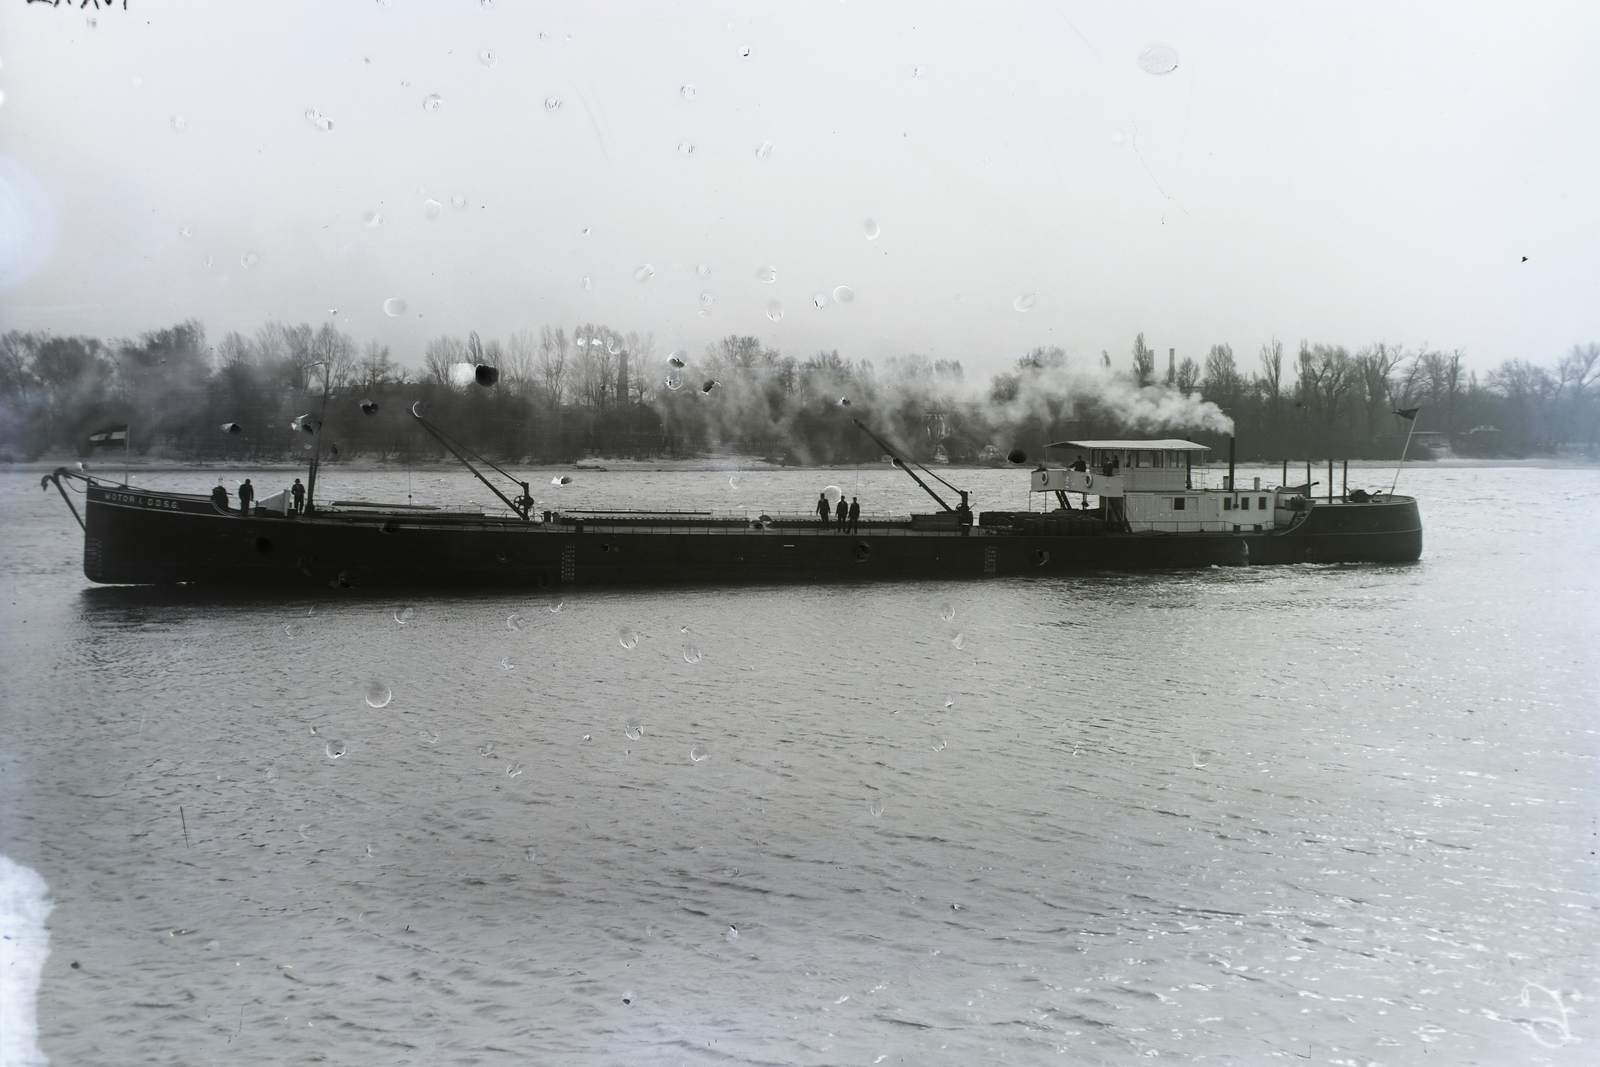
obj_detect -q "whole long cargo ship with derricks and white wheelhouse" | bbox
[42,405,1422,589]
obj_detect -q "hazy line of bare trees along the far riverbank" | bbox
[0,322,1600,462]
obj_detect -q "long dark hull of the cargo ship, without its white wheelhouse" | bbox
[72,470,1422,589]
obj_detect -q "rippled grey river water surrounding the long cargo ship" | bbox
[0,467,1600,1067]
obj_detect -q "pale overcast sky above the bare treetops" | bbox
[0,0,1600,373]
